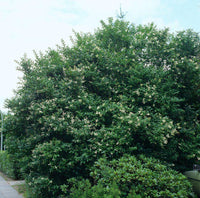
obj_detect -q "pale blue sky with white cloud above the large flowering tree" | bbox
[0,0,200,111]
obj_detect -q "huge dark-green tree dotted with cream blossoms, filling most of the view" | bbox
[4,18,200,198]
